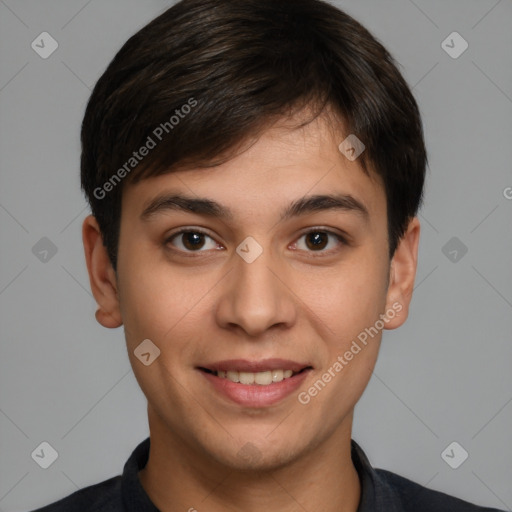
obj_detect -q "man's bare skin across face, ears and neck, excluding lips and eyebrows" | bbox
[83,112,420,512]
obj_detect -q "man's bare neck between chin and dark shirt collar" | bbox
[139,411,361,512]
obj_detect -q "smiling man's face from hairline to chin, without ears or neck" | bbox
[111,115,404,468]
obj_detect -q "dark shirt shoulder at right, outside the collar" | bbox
[375,469,501,512]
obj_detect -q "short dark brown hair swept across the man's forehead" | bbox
[81,0,427,269]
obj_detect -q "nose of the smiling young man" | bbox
[216,242,296,337]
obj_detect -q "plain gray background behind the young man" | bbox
[0,0,512,511]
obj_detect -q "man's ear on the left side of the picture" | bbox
[82,215,123,329]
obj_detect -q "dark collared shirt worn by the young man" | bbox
[33,437,504,512]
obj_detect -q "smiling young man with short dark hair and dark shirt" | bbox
[34,0,506,512]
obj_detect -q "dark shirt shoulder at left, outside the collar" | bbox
[32,475,123,512]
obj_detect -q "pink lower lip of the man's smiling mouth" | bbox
[199,369,310,407]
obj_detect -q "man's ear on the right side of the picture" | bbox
[385,217,420,329]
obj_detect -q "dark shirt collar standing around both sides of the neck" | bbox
[121,437,403,512]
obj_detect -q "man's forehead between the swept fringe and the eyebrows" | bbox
[122,118,386,227]
